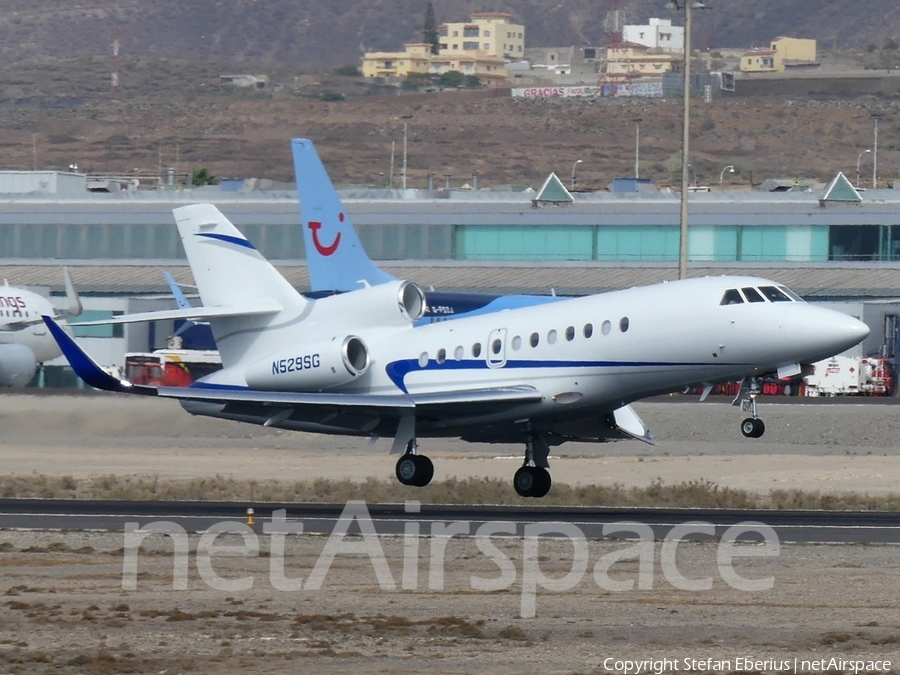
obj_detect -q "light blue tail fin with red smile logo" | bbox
[291,138,394,291]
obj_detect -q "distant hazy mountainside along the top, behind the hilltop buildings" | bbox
[0,0,900,67]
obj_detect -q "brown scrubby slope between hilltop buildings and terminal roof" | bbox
[0,59,900,188]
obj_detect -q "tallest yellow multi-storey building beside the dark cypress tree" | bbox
[438,12,525,59]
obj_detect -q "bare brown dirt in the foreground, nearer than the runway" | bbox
[0,532,900,675]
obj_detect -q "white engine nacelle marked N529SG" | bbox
[246,335,369,392]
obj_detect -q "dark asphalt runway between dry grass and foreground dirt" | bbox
[0,499,900,544]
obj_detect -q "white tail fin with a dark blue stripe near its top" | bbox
[173,204,307,310]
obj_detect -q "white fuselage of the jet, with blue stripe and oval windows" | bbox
[201,277,868,436]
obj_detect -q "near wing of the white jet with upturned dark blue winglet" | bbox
[43,316,541,417]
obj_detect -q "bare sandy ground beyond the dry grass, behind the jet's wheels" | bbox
[0,395,900,495]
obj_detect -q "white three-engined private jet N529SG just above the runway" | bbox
[45,209,869,497]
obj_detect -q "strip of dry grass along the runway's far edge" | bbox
[0,474,900,510]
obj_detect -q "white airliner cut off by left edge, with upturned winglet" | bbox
[0,268,81,387]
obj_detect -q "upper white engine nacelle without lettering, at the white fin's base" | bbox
[317,281,425,328]
